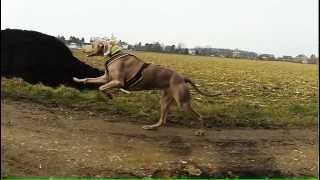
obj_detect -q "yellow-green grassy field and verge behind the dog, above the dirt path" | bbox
[1,51,318,128]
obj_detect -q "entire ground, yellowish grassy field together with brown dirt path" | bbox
[1,51,318,177]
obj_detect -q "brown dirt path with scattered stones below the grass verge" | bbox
[1,99,317,177]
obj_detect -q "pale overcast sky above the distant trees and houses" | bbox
[1,0,319,56]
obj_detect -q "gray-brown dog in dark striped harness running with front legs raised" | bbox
[73,41,219,135]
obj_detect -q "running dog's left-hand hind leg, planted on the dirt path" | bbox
[142,90,174,130]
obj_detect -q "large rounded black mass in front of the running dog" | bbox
[1,29,103,87]
